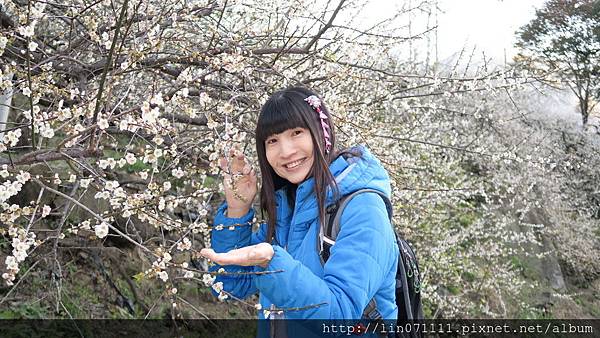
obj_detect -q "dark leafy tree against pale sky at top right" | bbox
[516,0,600,125]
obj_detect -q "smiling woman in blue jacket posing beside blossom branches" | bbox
[201,87,398,337]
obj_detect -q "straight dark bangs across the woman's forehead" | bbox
[256,96,311,145]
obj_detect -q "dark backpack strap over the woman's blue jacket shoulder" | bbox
[317,189,395,321]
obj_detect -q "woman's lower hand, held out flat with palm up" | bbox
[200,243,275,268]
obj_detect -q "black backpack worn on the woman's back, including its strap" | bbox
[317,189,424,336]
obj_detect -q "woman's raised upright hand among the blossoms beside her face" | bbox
[219,150,257,218]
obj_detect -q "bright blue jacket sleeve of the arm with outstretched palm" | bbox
[255,193,398,319]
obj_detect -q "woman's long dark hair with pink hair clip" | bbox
[255,87,339,243]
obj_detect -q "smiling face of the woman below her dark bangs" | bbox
[265,128,314,184]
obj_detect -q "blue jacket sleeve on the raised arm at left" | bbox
[209,202,266,299]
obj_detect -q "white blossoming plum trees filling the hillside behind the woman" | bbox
[0,0,600,318]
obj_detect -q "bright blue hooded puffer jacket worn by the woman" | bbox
[211,146,398,337]
